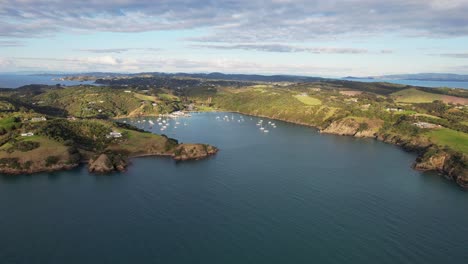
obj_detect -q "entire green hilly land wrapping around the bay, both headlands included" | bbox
[0,73,468,187]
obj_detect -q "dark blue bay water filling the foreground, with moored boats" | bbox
[0,113,468,264]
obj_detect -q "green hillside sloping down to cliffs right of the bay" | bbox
[186,82,468,186]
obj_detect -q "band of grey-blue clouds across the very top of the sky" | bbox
[0,0,468,43]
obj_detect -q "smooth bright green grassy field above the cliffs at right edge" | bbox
[427,128,468,154]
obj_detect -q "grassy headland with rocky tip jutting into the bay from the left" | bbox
[0,119,218,174]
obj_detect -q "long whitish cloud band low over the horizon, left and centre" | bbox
[0,56,351,75]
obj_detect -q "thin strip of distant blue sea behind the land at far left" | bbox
[0,74,95,88]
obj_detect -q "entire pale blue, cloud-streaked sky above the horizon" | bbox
[0,0,468,77]
